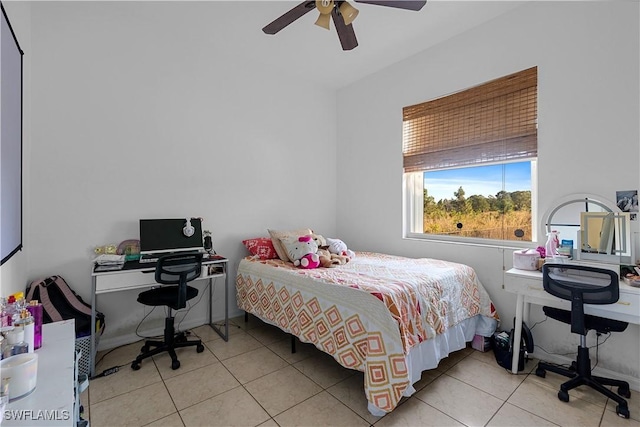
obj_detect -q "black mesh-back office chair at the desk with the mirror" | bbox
[536,264,631,418]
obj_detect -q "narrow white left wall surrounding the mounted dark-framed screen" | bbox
[0,1,32,297]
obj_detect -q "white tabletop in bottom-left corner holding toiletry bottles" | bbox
[2,320,76,427]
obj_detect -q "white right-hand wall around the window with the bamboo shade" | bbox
[337,2,640,378]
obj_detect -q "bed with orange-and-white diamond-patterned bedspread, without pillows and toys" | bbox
[236,252,498,416]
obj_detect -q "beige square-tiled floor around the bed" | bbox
[82,317,640,427]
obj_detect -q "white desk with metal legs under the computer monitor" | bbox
[89,255,229,377]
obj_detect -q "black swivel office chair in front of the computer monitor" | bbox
[131,254,204,371]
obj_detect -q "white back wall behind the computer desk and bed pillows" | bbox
[27,2,336,344]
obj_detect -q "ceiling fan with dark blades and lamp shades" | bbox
[262,0,427,50]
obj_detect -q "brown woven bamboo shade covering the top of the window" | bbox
[402,67,538,172]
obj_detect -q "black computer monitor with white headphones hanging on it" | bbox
[140,218,204,255]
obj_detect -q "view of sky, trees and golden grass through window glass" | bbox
[423,161,532,241]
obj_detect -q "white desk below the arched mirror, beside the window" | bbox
[504,268,640,374]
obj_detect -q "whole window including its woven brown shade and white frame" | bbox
[402,67,538,242]
